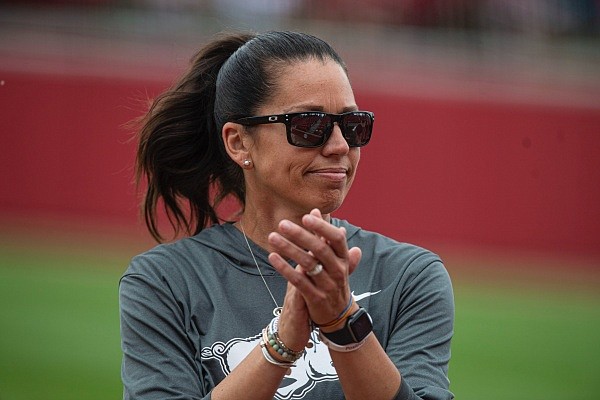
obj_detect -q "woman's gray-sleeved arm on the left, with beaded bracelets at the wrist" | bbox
[119,268,309,400]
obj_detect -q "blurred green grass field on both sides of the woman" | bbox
[0,239,600,400]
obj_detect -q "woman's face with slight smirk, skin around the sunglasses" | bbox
[246,59,360,215]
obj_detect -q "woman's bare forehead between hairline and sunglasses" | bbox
[265,58,355,112]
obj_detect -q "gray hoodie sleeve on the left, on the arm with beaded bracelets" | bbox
[119,266,210,400]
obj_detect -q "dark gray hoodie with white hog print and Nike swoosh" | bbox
[119,219,454,400]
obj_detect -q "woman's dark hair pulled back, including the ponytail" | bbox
[136,32,346,242]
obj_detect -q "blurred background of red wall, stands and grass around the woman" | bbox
[0,0,600,400]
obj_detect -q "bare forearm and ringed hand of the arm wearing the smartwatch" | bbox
[269,210,401,400]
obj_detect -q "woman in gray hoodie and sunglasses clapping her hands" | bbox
[120,32,453,400]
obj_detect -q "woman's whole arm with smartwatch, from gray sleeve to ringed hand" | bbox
[270,211,453,400]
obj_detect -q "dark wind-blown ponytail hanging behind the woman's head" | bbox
[136,34,253,242]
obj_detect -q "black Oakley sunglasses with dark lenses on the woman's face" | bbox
[232,111,375,147]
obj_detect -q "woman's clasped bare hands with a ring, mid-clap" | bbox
[268,209,362,348]
